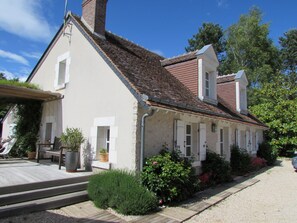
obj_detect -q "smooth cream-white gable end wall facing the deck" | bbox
[31,21,138,170]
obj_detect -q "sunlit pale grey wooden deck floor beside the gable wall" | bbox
[0,159,92,189]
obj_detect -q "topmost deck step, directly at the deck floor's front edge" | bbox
[0,176,90,195]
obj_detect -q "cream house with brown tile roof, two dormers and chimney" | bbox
[3,0,267,170]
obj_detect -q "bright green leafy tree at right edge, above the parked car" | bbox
[250,76,297,155]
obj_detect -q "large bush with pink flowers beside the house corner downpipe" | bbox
[141,150,198,204]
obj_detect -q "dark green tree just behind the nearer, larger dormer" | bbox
[185,23,225,60]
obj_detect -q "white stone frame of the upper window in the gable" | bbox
[54,52,71,90]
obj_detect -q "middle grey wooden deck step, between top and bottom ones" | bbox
[0,181,88,206]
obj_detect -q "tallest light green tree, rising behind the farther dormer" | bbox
[221,7,280,88]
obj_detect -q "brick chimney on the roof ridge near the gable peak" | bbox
[82,0,108,37]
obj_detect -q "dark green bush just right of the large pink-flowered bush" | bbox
[202,150,232,184]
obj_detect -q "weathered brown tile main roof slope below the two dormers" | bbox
[73,16,263,125]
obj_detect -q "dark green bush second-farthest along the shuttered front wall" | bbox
[230,145,251,174]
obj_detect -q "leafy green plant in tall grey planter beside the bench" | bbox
[61,128,85,172]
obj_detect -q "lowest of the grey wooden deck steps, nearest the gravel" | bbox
[0,191,88,218]
